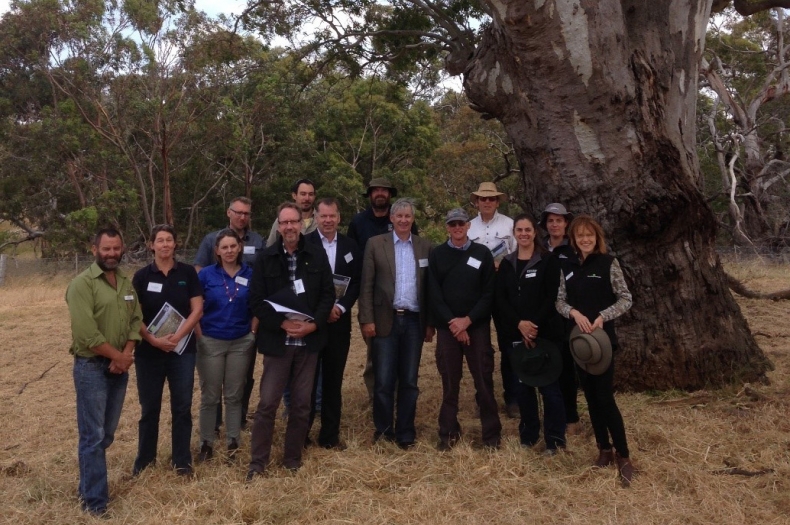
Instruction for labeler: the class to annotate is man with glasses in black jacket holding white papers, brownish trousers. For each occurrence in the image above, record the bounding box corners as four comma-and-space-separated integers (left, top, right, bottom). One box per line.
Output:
247, 203, 335, 481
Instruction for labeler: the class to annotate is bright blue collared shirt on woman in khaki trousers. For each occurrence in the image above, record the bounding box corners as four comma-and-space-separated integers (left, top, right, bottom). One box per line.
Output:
198, 263, 252, 341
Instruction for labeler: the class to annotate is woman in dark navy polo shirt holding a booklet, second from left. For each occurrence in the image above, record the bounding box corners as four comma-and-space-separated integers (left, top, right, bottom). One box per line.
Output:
132, 224, 203, 476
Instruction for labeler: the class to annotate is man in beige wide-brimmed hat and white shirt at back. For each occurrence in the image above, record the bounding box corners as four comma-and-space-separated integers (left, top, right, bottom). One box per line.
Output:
468, 182, 520, 418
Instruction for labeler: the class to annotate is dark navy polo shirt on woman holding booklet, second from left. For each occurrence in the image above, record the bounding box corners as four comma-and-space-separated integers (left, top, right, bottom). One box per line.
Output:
132, 261, 203, 353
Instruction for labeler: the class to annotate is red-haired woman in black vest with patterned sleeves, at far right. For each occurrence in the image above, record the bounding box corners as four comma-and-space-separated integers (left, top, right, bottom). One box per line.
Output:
557, 215, 634, 483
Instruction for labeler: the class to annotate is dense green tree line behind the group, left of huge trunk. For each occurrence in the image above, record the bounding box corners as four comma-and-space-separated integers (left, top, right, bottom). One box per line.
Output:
0, 0, 513, 256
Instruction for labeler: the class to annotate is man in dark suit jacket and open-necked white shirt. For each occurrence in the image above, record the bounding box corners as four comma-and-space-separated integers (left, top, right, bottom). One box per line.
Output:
307, 197, 362, 450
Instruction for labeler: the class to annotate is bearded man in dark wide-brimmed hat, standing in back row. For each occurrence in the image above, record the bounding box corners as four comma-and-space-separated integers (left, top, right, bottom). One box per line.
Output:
346, 177, 417, 403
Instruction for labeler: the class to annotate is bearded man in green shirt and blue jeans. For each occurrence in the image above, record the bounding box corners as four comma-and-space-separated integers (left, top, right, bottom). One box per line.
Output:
66, 228, 143, 515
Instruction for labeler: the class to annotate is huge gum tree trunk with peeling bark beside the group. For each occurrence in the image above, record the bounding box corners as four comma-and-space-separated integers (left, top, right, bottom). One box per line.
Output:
464, 0, 772, 390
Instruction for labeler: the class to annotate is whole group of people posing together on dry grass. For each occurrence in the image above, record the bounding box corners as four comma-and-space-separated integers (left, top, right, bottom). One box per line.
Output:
66, 178, 634, 514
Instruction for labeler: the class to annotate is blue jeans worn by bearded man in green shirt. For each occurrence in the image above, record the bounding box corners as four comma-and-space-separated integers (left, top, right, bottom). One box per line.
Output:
73, 357, 129, 513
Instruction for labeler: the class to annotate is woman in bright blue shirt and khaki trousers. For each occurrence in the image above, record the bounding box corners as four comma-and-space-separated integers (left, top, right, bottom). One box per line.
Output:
197, 229, 258, 462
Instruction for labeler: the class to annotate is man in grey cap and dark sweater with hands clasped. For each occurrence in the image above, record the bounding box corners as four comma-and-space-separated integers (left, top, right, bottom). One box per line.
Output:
428, 208, 502, 451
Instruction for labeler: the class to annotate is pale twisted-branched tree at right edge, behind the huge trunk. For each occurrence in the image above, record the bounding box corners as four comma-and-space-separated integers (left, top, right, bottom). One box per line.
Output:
699, 9, 790, 246
